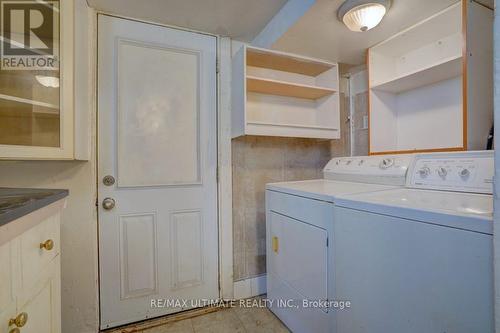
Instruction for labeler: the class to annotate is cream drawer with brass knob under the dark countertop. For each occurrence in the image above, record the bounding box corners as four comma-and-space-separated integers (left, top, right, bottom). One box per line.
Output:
20, 214, 60, 288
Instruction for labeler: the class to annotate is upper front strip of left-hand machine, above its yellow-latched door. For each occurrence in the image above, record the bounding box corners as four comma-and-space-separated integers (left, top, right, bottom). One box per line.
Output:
266, 190, 333, 230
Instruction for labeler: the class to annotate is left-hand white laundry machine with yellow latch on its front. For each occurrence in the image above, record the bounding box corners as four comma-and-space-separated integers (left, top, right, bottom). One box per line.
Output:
266, 155, 412, 333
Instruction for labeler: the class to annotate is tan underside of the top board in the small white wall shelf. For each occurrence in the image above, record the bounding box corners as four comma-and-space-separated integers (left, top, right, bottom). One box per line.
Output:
247, 48, 335, 76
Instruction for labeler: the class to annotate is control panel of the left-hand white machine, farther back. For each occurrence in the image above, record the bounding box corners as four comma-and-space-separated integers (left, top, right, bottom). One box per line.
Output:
323, 154, 413, 185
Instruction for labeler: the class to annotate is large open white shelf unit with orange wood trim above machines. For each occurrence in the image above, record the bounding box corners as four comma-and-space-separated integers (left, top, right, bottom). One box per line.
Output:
367, 0, 493, 154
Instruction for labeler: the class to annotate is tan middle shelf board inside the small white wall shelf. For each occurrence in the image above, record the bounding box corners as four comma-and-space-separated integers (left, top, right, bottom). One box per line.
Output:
247, 76, 335, 100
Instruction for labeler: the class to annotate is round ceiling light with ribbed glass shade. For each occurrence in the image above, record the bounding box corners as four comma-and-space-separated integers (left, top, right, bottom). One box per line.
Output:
337, 0, 391, 32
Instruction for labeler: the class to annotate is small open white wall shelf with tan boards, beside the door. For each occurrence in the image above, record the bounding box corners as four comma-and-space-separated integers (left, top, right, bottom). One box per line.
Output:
232, 46, 340, 139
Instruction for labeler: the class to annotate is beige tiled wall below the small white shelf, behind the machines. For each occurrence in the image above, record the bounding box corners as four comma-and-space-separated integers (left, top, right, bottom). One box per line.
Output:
232, 89, 349, 281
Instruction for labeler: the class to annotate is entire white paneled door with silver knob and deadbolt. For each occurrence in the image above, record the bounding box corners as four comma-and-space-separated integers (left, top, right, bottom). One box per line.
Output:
98, 15, 219, 328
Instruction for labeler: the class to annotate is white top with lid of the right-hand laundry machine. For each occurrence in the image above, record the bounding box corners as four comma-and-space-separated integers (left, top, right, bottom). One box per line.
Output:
335, 188, 493, 234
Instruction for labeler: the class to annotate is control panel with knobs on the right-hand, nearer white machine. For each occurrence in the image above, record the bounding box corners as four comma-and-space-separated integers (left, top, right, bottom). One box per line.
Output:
406, 151, 494, 193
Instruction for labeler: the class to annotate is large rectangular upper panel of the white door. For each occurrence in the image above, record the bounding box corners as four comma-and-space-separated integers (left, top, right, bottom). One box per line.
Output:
117, 40, 200, 186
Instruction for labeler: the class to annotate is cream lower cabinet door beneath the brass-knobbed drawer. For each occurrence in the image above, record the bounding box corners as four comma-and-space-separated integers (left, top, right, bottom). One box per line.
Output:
17, 256, 61, 333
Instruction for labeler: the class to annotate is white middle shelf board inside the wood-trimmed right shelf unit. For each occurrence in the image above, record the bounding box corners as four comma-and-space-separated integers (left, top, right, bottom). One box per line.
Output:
371, 55, 462, 93
